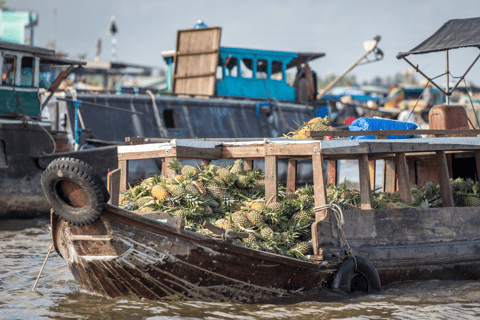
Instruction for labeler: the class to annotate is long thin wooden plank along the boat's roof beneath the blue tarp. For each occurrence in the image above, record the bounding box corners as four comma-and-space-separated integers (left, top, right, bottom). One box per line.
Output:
305, 129, 480, 139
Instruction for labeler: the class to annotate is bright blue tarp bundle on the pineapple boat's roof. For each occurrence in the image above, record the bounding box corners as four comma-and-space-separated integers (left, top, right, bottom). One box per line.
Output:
349, 118, 418, 140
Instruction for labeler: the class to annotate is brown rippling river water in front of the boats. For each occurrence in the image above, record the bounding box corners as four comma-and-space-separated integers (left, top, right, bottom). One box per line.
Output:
0, 219, 480, 319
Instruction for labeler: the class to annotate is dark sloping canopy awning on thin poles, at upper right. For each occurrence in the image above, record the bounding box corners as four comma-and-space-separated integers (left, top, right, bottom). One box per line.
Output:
397, 18, 480, 59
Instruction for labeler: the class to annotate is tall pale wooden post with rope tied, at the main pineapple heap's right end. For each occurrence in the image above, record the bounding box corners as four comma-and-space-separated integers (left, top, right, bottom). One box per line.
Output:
312, 152, 328, 255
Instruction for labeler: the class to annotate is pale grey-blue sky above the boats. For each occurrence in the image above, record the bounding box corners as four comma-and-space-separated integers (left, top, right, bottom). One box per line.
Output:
10, 0, 480, 85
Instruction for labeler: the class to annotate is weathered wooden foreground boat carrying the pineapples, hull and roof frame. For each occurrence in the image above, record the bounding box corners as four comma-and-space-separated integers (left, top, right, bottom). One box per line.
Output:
44, 130, 480, 302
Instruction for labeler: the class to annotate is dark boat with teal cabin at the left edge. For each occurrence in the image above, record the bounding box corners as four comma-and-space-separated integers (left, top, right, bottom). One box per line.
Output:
0, 41, 117, 218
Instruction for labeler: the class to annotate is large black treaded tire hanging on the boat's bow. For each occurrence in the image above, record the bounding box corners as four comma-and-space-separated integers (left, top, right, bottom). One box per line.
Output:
41, 158, 109, 226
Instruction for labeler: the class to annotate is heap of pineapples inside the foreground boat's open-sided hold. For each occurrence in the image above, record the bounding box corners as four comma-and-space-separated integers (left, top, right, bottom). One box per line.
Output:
120, 160, 480, 259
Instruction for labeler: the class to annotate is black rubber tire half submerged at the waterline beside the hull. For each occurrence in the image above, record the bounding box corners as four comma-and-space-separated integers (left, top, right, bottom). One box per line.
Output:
332, 256, 382, 294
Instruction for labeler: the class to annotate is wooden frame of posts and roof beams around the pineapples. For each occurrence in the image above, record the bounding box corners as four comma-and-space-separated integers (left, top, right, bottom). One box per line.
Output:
118, 138, 480, 255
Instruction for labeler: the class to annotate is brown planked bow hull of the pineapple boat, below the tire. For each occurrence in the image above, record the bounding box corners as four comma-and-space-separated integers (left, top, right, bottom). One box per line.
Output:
52, 206, 335, 302
